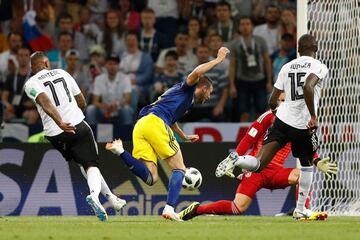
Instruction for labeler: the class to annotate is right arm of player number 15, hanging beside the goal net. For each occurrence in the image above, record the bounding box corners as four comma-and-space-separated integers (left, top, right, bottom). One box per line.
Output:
304, 73, 319, 129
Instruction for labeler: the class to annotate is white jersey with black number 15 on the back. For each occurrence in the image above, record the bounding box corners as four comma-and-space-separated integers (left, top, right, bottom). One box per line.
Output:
274, 56, 329, 129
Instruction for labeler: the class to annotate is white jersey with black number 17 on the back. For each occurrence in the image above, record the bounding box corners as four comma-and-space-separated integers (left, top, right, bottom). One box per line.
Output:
25, 69, 85, 136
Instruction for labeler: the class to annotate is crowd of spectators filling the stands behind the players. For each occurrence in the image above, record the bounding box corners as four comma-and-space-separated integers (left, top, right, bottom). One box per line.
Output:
0, 0, 296, 124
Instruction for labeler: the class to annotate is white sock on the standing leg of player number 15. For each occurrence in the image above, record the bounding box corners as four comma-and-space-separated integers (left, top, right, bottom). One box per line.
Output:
296, 166, 313, 211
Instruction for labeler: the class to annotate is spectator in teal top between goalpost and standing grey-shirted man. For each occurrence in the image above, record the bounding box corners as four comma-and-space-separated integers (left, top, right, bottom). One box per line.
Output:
271, 33, 296, 81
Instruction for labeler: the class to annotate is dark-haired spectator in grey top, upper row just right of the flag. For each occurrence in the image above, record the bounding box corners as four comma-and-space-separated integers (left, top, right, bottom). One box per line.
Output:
57, 12, 89, 63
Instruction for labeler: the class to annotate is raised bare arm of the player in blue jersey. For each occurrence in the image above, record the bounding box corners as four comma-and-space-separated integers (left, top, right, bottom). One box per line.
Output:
186, 47, 230, 86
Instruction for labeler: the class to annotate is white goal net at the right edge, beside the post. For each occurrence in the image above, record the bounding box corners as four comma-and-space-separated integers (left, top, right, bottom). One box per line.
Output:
306, 0, 360, 215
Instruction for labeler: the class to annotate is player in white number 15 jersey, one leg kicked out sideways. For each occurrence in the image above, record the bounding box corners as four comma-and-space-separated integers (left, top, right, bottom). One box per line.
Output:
216, 34, 328, 219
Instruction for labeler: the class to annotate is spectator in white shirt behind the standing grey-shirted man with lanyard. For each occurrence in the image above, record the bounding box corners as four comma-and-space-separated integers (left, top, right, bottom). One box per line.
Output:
254, 5, 281, 55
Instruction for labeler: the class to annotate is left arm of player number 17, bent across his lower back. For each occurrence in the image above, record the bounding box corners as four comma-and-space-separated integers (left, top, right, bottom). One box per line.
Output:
35, 93, 76, 133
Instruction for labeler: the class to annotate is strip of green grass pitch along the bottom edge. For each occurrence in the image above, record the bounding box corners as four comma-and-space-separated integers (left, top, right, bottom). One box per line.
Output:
0, 216, 360, 240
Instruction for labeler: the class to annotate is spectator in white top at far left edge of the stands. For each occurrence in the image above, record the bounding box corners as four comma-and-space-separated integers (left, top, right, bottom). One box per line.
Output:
0, 32, 23, 79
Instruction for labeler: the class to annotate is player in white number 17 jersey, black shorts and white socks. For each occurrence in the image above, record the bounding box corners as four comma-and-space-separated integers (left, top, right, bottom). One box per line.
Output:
25, 52, 126, 221
